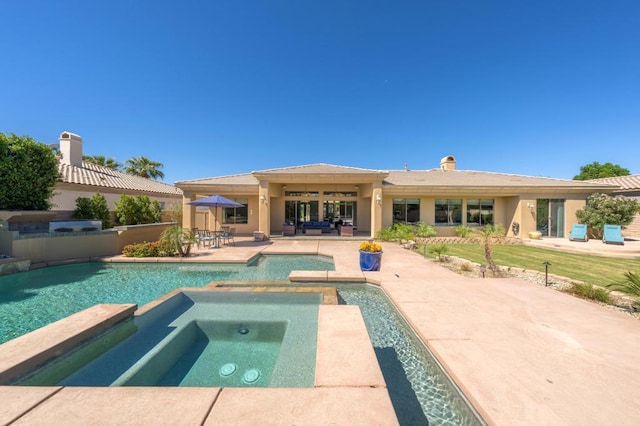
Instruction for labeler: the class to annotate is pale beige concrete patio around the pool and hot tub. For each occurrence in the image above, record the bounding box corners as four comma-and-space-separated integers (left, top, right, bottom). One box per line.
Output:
0, 238, 640, 425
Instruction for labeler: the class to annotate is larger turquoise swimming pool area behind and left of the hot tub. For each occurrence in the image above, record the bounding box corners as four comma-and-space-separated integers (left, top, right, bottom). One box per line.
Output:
0, 255, 335, 343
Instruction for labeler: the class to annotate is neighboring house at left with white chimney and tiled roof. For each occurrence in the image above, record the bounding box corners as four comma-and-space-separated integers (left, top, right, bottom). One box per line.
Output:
51, 132, 182, 219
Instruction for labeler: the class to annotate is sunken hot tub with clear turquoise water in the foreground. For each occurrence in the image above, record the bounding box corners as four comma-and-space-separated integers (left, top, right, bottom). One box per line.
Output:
18, 291, 322, 387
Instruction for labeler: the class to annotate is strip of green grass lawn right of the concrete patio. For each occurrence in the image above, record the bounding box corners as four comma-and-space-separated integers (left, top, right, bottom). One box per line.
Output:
419, 244, 640, 285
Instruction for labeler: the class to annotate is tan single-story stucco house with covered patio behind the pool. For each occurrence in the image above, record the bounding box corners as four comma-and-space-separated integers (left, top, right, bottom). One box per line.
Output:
176, 156, 618, 237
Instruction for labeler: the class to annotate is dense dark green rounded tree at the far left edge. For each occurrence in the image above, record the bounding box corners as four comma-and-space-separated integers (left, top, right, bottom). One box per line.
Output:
0, 133, 60, 210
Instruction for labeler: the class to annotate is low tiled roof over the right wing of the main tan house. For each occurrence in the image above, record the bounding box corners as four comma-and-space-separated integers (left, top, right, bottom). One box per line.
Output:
384, 169, 611, 189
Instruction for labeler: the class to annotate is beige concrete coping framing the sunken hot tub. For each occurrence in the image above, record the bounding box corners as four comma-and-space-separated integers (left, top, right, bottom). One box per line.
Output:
0, 283, 397, 424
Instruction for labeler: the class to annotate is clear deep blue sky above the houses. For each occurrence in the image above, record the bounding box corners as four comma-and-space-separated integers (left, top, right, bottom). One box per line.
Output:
0, 0, 640, 183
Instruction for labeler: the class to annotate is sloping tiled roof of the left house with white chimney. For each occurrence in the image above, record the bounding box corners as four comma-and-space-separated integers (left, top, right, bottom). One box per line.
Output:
58, 162, 182, 195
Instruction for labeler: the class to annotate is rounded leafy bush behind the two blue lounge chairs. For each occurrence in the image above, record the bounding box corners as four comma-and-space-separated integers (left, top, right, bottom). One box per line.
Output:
576, 194, 640, 238
